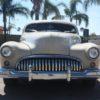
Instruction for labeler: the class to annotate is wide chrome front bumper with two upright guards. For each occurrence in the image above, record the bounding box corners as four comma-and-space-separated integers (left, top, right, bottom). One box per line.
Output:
0, 68, 100, 81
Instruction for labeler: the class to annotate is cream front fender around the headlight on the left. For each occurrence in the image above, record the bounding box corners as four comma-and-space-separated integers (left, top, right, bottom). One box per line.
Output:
0, 41, 31, 67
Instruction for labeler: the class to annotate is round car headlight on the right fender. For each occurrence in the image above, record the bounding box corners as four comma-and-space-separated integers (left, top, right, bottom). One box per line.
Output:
88, 47, 99, 59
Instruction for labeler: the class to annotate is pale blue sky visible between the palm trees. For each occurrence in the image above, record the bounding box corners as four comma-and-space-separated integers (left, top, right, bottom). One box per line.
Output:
0, 0, 100, 35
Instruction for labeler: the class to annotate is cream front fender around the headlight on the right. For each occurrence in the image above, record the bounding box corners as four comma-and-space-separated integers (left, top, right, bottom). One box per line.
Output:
70, 43, 100, 68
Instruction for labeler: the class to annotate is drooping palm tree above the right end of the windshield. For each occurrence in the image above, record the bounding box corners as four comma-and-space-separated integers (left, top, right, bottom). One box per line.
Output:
64, 0, 89, 26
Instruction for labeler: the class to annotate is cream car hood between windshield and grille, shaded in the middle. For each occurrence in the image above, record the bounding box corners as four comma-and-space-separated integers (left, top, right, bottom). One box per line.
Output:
21, 32, 80, 55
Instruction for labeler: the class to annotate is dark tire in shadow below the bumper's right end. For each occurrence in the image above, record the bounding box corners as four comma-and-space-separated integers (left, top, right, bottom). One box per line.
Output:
82, 79, 97, 89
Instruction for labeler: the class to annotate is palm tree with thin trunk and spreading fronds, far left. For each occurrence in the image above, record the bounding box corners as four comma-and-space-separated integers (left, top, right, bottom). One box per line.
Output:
0, 0, 29, 41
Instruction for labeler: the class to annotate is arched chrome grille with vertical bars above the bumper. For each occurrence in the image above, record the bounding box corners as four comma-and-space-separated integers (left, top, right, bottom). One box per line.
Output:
16, 55, 83, 71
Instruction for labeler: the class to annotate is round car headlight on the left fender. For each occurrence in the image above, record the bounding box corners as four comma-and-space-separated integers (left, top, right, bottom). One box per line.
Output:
1, 46, 12, 57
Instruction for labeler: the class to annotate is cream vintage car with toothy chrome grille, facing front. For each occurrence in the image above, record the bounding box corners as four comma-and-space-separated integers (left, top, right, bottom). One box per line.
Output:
0, 20, 100, 86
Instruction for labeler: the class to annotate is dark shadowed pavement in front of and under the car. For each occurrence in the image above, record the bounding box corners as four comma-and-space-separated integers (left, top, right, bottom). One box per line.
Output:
0, 79, 100, 100
